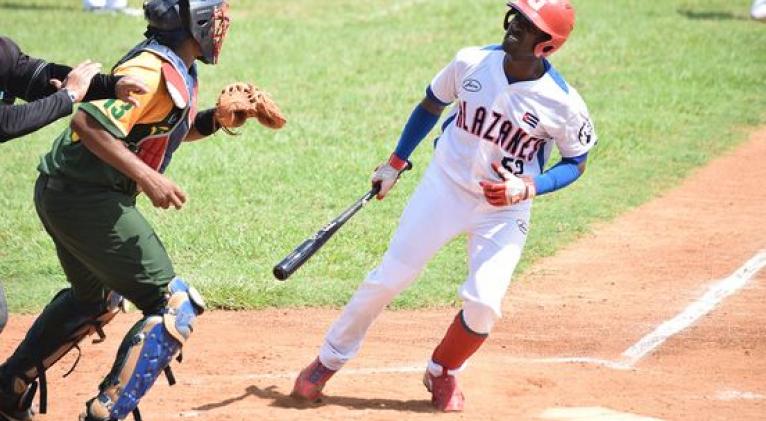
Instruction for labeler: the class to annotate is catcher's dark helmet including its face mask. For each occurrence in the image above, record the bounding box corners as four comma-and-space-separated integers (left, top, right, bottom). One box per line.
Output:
144, 0, 229, 64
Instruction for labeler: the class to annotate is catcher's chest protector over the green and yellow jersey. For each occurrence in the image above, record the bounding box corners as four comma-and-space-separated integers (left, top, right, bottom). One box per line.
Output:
115, 39, 197, 173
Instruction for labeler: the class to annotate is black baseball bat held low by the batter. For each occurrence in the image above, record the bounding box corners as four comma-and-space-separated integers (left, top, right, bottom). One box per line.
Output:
274, 184, 380, 281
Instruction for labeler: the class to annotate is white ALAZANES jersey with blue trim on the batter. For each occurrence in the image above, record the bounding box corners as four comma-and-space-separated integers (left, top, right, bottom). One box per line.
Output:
427, 46, 596, 202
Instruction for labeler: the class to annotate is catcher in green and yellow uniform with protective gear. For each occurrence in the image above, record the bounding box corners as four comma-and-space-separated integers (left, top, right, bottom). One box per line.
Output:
0, 0, 285, 421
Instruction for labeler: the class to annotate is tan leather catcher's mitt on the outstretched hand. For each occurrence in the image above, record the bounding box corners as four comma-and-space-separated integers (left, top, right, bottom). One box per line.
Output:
215, 82, 286, 134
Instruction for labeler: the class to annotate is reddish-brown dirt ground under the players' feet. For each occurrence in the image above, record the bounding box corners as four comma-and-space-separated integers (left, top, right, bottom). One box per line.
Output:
0, 131, 766, 421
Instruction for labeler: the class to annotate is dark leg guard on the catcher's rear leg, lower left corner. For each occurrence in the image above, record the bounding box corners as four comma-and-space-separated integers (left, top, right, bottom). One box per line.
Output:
0, 289, 123, 420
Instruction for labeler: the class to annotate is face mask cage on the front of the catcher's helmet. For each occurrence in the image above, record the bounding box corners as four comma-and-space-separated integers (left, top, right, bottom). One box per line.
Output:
182, 0, 229, 64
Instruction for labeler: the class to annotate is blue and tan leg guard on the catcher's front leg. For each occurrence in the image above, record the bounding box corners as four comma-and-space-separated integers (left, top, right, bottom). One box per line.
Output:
81, 278, 205, 421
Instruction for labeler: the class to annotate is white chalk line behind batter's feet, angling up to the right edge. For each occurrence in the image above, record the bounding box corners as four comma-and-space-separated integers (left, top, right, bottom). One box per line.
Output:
181, 250, 766, 384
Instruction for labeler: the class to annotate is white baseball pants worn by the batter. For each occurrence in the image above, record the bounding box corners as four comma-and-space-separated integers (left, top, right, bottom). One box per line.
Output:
319, 162, 530, 370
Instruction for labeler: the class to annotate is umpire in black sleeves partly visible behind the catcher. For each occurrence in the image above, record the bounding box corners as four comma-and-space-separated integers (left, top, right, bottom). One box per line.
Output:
0, 36, 147, 332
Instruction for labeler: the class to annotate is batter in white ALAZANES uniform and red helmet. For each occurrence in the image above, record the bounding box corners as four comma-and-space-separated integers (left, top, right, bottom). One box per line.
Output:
292, 0, 596, 411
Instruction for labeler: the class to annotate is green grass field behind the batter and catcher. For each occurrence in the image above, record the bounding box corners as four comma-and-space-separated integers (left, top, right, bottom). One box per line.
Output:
0, 0, 766, 311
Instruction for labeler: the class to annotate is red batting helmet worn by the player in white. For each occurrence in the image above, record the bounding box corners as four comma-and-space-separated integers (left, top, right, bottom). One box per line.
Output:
506, 0, 575, 57
